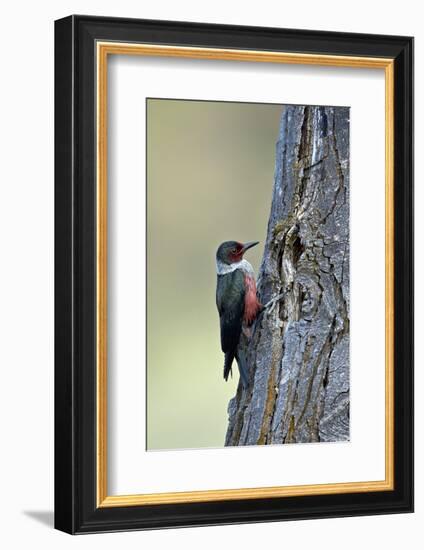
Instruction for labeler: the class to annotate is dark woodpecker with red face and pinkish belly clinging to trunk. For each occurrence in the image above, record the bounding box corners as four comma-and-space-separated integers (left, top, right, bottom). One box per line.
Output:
216, 241, 263, 388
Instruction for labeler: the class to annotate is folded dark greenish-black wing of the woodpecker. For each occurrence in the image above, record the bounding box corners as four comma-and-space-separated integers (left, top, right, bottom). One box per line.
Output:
216, 269, 245, 353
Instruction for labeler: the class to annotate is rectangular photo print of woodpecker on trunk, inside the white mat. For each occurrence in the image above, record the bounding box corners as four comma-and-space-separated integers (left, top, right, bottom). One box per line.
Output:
146, 98, 350, 451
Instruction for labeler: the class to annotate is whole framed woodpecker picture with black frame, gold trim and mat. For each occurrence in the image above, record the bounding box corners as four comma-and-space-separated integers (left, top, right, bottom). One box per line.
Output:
55, 16, 413, 534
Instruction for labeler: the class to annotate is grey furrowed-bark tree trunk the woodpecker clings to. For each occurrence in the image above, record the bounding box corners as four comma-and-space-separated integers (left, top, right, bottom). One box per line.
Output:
225, 106, 349, 445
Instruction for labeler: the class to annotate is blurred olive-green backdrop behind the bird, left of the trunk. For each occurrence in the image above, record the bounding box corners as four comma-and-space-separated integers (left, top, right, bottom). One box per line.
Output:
147, 99, 282, 450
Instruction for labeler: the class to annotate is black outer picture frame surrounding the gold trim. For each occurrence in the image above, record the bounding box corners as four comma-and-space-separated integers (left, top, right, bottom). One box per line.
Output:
55, 15, 413, 534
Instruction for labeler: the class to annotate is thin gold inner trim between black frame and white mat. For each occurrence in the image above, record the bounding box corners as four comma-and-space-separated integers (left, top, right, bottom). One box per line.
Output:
96, 41, 394, 507
